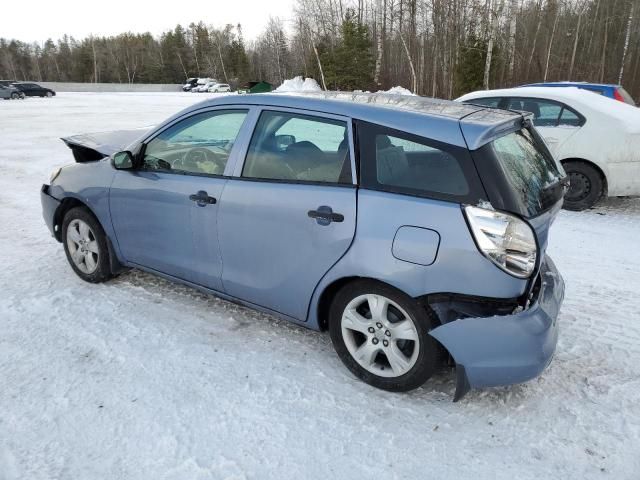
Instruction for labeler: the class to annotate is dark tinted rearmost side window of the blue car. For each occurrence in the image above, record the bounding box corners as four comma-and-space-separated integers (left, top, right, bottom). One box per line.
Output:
357, 122, 482, 201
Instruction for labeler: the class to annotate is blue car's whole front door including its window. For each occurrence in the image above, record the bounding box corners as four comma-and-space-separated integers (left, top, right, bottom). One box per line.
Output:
109, 110, 247, 291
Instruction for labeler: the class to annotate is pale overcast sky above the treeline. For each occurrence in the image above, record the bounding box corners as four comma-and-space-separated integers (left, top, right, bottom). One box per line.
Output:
0, 0, 294, 42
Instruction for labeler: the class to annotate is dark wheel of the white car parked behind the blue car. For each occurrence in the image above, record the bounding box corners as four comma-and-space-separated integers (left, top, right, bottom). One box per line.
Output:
563, 161, 604, 212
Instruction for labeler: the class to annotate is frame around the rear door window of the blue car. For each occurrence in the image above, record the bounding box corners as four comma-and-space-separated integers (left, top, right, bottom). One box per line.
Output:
230, 105, 358, 187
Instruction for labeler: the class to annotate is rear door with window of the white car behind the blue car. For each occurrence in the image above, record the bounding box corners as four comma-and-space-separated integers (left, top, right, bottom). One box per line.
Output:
507, 97, 584, 156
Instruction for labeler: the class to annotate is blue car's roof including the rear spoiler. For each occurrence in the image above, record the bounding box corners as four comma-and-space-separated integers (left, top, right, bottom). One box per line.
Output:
185, 92, 523, 150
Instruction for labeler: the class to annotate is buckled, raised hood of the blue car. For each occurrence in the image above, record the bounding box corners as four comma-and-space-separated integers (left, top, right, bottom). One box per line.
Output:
61, 127, 153, 163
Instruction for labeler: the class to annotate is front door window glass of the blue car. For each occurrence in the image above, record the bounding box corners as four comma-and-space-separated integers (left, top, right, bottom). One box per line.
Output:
142, 110, 247, 175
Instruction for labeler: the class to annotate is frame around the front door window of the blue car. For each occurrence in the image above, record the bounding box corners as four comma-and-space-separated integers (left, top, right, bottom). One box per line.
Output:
135, 104, 255, 178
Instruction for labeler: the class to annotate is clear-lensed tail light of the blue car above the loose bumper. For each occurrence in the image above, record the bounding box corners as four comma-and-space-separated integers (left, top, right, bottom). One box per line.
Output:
464, 206, 538, 278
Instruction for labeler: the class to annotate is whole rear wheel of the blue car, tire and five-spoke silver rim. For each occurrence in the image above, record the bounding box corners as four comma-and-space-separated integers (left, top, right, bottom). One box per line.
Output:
329, 280, 439, 392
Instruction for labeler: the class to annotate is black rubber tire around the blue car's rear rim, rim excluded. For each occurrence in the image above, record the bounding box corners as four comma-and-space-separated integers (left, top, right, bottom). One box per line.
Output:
329, 280, 441, 392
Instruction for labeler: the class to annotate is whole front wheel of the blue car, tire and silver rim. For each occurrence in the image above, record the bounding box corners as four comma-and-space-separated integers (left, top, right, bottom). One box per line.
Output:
62, 207, 112, 283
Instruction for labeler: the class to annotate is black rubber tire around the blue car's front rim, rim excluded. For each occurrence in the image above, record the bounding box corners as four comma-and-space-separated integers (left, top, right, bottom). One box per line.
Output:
62, 207, 113, 283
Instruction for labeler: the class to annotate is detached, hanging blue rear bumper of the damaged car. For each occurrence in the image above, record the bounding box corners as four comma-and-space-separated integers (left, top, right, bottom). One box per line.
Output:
430, 256, 564, 401
